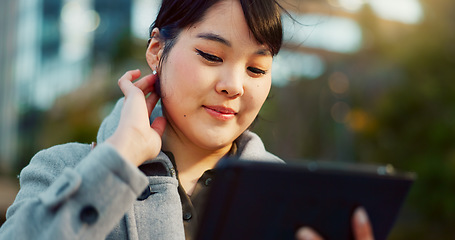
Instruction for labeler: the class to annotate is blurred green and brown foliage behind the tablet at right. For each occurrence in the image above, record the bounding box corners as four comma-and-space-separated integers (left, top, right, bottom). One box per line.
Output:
256, 0, 455, 239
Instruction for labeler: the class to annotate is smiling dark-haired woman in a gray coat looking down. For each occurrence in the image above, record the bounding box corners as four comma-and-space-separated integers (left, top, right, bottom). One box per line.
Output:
0, 0, 371, 239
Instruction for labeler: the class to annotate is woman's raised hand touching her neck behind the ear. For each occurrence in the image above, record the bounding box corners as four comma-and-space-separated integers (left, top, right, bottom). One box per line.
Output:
106, 70, 166, 166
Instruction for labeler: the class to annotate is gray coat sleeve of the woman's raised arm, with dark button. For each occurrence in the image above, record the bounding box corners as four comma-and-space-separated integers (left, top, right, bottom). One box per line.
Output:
0, 143, 148, 240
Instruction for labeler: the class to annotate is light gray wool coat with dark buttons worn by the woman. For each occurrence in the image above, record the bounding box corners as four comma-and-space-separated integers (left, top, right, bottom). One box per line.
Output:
0, 99, 281, 240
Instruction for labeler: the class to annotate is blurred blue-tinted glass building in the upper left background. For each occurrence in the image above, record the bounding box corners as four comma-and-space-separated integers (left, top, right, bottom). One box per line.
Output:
0, 0, 132, 172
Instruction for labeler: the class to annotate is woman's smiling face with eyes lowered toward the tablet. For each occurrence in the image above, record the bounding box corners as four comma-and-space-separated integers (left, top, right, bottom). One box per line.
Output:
149, 0, 272, 150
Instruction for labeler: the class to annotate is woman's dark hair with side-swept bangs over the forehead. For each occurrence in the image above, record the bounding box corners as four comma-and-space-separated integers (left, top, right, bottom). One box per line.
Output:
150, 0, 283, 65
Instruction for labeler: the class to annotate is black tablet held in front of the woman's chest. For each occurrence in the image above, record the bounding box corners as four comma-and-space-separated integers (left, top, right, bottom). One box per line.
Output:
196, 160, 415, 240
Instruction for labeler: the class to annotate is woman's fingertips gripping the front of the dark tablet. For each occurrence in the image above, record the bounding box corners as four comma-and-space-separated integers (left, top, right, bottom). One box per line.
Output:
295, 207, 374, 240
